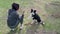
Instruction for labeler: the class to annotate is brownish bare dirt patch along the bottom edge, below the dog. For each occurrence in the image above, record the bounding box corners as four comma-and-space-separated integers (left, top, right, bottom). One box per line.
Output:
26, 24, 56, 34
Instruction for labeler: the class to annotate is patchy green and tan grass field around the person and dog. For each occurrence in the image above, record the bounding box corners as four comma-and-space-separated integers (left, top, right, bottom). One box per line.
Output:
0, 0, 60, 34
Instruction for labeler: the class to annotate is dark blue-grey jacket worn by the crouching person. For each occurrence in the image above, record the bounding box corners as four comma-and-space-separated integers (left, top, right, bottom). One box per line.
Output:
7, 9, 24, 28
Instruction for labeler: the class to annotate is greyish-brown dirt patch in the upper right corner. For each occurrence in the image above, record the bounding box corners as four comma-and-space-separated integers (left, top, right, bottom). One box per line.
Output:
45, 1, 60, 18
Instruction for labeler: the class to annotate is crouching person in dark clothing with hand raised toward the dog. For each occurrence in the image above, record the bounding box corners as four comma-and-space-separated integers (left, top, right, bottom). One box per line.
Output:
7, 3, 24, 30
